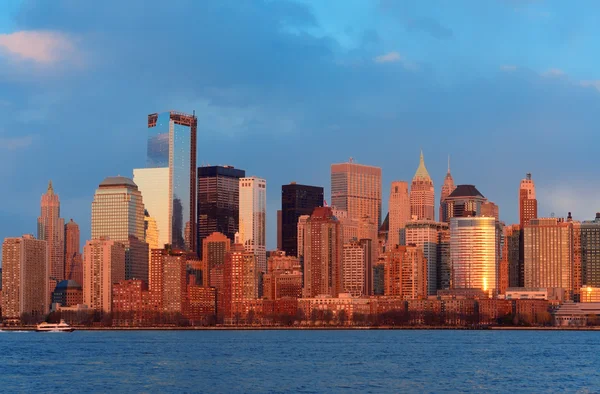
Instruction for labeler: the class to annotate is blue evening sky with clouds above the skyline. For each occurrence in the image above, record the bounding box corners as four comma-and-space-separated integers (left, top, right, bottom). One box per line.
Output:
0, 0, 600, 252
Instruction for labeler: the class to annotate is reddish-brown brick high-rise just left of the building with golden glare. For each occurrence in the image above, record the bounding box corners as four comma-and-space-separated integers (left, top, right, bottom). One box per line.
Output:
383, 245, 427, 300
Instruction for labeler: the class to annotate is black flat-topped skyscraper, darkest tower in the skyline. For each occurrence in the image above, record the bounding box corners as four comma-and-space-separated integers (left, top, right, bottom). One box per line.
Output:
281, 182, 323, 256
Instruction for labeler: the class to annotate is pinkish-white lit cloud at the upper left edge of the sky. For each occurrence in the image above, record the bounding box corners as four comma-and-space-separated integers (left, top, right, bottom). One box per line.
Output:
0, 30, 75, 65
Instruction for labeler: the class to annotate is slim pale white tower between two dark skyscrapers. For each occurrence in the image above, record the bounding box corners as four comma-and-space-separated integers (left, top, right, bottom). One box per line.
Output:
240, 177, 267, 272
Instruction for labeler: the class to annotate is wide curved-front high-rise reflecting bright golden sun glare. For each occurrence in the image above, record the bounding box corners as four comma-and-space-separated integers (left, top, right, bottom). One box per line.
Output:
450, 216, 498, 297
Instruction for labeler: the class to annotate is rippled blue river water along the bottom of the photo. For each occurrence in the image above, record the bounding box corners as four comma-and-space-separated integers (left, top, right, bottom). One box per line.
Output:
0, 330, 600, 393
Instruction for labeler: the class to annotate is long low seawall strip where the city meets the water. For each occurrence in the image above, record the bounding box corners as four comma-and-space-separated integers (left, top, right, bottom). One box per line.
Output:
0, 326, 600, 332
